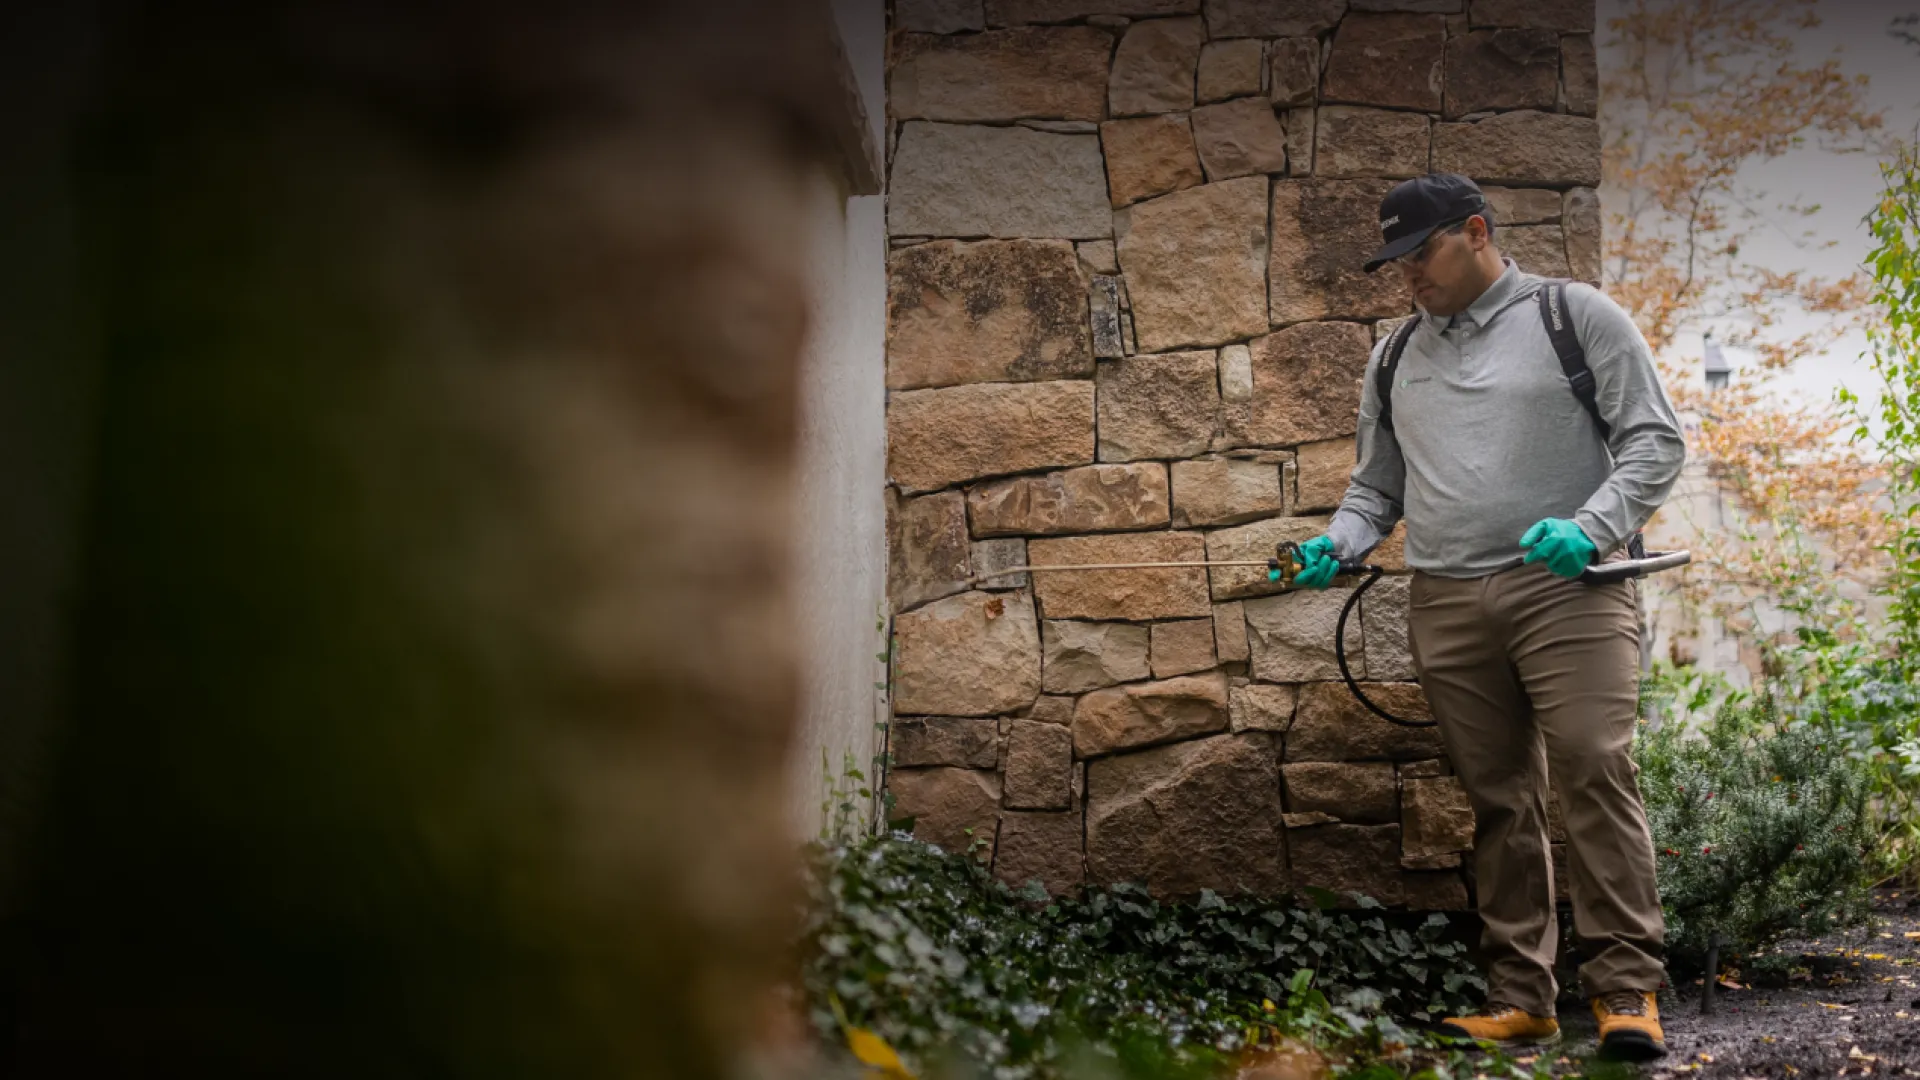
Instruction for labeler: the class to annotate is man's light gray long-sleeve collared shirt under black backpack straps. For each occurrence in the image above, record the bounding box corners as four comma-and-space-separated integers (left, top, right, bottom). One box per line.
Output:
1327, 259, 1686, 578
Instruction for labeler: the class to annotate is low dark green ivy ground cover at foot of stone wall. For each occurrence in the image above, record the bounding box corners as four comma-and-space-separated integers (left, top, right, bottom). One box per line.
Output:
804, 836, 1484, 1080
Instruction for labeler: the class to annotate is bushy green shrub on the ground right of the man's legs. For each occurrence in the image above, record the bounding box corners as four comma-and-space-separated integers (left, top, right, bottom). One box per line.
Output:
1634, 698, 1874, 974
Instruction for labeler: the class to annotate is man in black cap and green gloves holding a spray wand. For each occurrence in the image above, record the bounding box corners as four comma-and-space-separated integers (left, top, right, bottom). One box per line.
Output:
1296, 173, 1686, 1059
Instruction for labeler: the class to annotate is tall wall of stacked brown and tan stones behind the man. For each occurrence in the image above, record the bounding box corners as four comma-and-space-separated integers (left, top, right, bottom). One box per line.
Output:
887, 0, 1599, 909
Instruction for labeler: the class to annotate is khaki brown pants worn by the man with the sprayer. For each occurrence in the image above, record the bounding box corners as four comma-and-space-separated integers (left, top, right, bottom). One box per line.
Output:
1409, 565, 1665, 1017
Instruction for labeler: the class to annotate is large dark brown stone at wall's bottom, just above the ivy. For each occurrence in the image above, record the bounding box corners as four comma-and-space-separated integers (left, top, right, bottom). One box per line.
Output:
1087, 732, 1286, 897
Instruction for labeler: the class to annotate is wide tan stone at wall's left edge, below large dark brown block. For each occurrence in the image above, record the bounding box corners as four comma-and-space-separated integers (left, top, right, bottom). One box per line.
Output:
887, 380, 1094, 492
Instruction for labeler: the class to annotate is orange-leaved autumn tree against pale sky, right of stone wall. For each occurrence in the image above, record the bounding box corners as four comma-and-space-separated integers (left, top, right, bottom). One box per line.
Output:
1601, 0, 1891, 630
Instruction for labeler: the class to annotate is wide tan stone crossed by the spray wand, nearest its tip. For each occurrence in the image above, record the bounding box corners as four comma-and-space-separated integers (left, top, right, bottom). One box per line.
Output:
1027, 532, 1212, 623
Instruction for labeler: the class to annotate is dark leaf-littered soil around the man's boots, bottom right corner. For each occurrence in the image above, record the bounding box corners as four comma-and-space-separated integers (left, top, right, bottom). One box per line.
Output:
1505, 890, 1920, 1080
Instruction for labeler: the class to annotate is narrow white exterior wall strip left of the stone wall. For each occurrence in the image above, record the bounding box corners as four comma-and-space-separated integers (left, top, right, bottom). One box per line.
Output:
789, 0, 887, 838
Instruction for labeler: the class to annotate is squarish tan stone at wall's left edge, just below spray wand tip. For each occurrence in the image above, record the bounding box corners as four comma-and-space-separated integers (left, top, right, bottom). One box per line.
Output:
893, 592, 1041, 717
